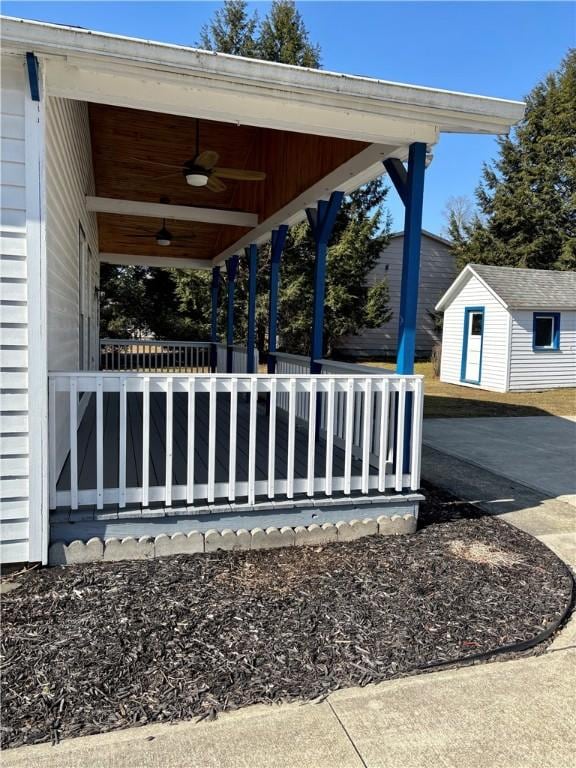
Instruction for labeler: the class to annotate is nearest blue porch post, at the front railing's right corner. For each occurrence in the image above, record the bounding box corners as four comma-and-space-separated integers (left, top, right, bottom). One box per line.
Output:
384, 142, 426, 471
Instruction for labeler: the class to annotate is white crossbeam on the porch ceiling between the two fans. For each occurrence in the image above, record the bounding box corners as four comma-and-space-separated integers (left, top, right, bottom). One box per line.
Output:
86, 195, 258, 227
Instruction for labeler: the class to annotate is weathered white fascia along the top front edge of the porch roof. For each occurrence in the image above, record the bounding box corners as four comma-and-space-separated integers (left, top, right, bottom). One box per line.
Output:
2, 18, 525, 142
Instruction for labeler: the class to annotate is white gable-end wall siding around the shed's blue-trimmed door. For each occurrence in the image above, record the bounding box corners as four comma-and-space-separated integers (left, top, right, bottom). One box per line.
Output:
440, 277, 510, 392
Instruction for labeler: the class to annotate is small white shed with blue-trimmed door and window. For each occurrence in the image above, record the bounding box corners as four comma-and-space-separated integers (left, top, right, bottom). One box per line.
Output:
436, 264, 576, 392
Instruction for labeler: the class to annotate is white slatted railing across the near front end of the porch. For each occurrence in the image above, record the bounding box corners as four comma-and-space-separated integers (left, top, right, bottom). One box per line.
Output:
49, 372, 423, 510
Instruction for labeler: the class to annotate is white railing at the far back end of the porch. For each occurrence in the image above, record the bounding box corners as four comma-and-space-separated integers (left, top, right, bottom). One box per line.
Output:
100, 339, 210, 373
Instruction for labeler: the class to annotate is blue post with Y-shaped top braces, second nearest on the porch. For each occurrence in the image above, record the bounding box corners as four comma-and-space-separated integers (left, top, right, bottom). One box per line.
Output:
306, 192, 344, 373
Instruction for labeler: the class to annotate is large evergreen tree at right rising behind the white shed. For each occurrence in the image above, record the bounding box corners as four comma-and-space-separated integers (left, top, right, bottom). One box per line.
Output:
449, 50, 576, 269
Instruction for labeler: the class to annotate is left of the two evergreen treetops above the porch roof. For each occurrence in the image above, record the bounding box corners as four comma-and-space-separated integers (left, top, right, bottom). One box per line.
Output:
199, 0, 258, 57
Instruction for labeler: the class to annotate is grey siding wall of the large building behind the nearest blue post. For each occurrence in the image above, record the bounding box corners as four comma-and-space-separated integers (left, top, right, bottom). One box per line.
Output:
337, 233, 456, 358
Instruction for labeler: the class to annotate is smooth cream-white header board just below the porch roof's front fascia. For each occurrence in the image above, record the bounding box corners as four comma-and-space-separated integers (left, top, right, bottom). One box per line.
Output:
46, 59, 438, 145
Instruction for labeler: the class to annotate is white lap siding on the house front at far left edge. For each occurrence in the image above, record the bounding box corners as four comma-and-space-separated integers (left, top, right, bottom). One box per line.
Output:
0, 56, 30, 562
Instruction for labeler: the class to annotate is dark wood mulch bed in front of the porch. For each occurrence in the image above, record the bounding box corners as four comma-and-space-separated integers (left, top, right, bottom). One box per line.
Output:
2, 488, 571, 746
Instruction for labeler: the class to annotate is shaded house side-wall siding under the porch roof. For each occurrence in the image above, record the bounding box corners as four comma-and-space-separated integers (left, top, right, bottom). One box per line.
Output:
46, 97, 99, 471
